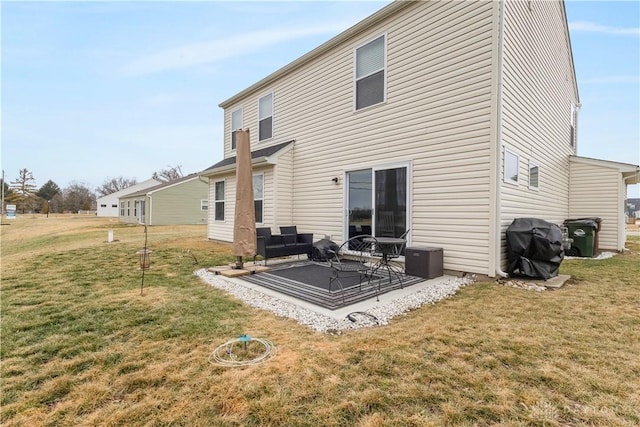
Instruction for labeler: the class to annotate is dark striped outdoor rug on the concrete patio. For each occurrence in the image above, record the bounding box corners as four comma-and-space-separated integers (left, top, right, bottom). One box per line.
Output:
240, 261, 424, 310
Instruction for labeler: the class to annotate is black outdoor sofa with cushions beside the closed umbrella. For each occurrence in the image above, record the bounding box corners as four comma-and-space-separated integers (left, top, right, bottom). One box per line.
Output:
256, 225, 313, 265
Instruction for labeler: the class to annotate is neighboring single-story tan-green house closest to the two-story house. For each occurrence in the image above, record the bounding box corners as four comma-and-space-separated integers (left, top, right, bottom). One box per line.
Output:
119, 174, 209, 225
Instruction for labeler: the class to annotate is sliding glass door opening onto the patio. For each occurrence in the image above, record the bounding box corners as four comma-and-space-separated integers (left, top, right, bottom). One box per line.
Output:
345, 166, 408, 241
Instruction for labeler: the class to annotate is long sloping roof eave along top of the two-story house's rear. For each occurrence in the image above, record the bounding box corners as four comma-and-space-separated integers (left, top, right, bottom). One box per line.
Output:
218, 0, 414, 108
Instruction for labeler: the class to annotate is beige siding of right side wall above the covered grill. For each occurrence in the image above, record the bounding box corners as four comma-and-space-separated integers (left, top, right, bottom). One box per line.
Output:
498, 0, 578, 265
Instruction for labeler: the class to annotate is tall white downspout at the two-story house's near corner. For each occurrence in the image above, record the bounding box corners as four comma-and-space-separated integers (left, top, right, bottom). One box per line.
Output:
494, 1, 508, 277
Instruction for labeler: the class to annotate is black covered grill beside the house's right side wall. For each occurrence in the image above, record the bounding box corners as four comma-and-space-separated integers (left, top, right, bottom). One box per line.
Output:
507, 218, 564, 280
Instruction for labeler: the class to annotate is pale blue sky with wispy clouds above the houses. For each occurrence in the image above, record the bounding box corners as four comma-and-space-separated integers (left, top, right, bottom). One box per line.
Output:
1, 0, 640, 197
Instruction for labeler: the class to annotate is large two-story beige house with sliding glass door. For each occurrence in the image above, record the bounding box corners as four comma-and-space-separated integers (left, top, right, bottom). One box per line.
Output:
200, 0, 639, 276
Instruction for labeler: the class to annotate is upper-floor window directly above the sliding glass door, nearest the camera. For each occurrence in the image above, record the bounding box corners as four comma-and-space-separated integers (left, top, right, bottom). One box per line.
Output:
355, 35, 386, 110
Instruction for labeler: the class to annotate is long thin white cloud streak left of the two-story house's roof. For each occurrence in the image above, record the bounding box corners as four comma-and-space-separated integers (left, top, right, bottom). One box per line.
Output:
120, 23, 356, 76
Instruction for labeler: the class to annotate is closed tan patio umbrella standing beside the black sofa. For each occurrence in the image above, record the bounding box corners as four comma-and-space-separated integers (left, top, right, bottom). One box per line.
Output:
233, 129, 256, 268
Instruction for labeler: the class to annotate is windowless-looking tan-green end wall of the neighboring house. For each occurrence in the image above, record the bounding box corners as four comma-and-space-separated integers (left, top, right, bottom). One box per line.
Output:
147, 178, 208, 225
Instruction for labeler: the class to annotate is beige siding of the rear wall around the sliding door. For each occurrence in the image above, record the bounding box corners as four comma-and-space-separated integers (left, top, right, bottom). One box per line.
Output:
220, 2, 495, 273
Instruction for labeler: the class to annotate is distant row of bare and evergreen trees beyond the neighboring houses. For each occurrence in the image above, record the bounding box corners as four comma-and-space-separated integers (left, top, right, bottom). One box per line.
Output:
0, 166, 183, 214
